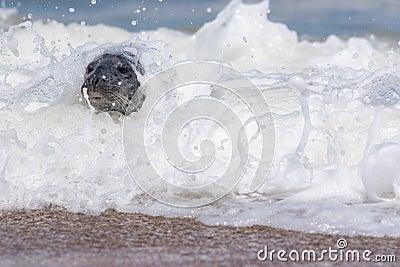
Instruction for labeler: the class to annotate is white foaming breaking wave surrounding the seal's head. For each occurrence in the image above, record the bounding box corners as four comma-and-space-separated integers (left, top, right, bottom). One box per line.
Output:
0, 0, 400, 236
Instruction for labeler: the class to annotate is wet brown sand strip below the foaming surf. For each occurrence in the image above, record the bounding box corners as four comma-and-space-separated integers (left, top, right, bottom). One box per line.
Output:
0, 208, 400, 266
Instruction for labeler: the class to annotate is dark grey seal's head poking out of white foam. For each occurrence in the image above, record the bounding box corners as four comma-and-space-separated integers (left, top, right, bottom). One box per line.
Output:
81, 53, 145, 115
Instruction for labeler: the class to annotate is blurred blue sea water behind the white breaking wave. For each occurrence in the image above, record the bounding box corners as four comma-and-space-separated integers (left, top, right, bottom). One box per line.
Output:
3, 0, 400, 38
